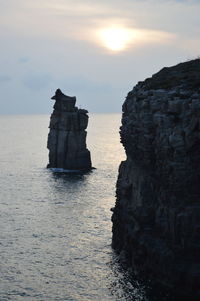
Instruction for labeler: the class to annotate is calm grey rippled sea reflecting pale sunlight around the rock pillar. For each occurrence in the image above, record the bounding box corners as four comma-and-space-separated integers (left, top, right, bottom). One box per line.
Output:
0, 114, 147, 301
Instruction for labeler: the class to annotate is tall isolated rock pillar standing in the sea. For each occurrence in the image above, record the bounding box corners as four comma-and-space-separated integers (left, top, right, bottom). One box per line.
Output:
47, 89, 92, 171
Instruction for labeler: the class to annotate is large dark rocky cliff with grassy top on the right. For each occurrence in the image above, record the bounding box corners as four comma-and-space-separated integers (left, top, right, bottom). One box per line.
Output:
112, 59, 200, 296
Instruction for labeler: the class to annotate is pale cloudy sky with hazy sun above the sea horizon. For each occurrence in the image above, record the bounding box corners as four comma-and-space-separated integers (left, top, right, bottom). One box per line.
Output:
0, 0, 200, 114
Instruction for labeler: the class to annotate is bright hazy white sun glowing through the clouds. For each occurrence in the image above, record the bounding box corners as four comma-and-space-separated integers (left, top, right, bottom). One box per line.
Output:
99, 26, 133, 51
